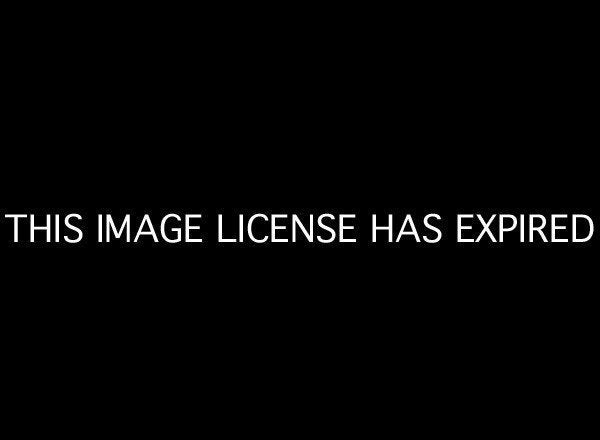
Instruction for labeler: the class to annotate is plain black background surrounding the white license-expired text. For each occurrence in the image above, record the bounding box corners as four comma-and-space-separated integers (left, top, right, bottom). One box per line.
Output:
1, 5, 598, 433
